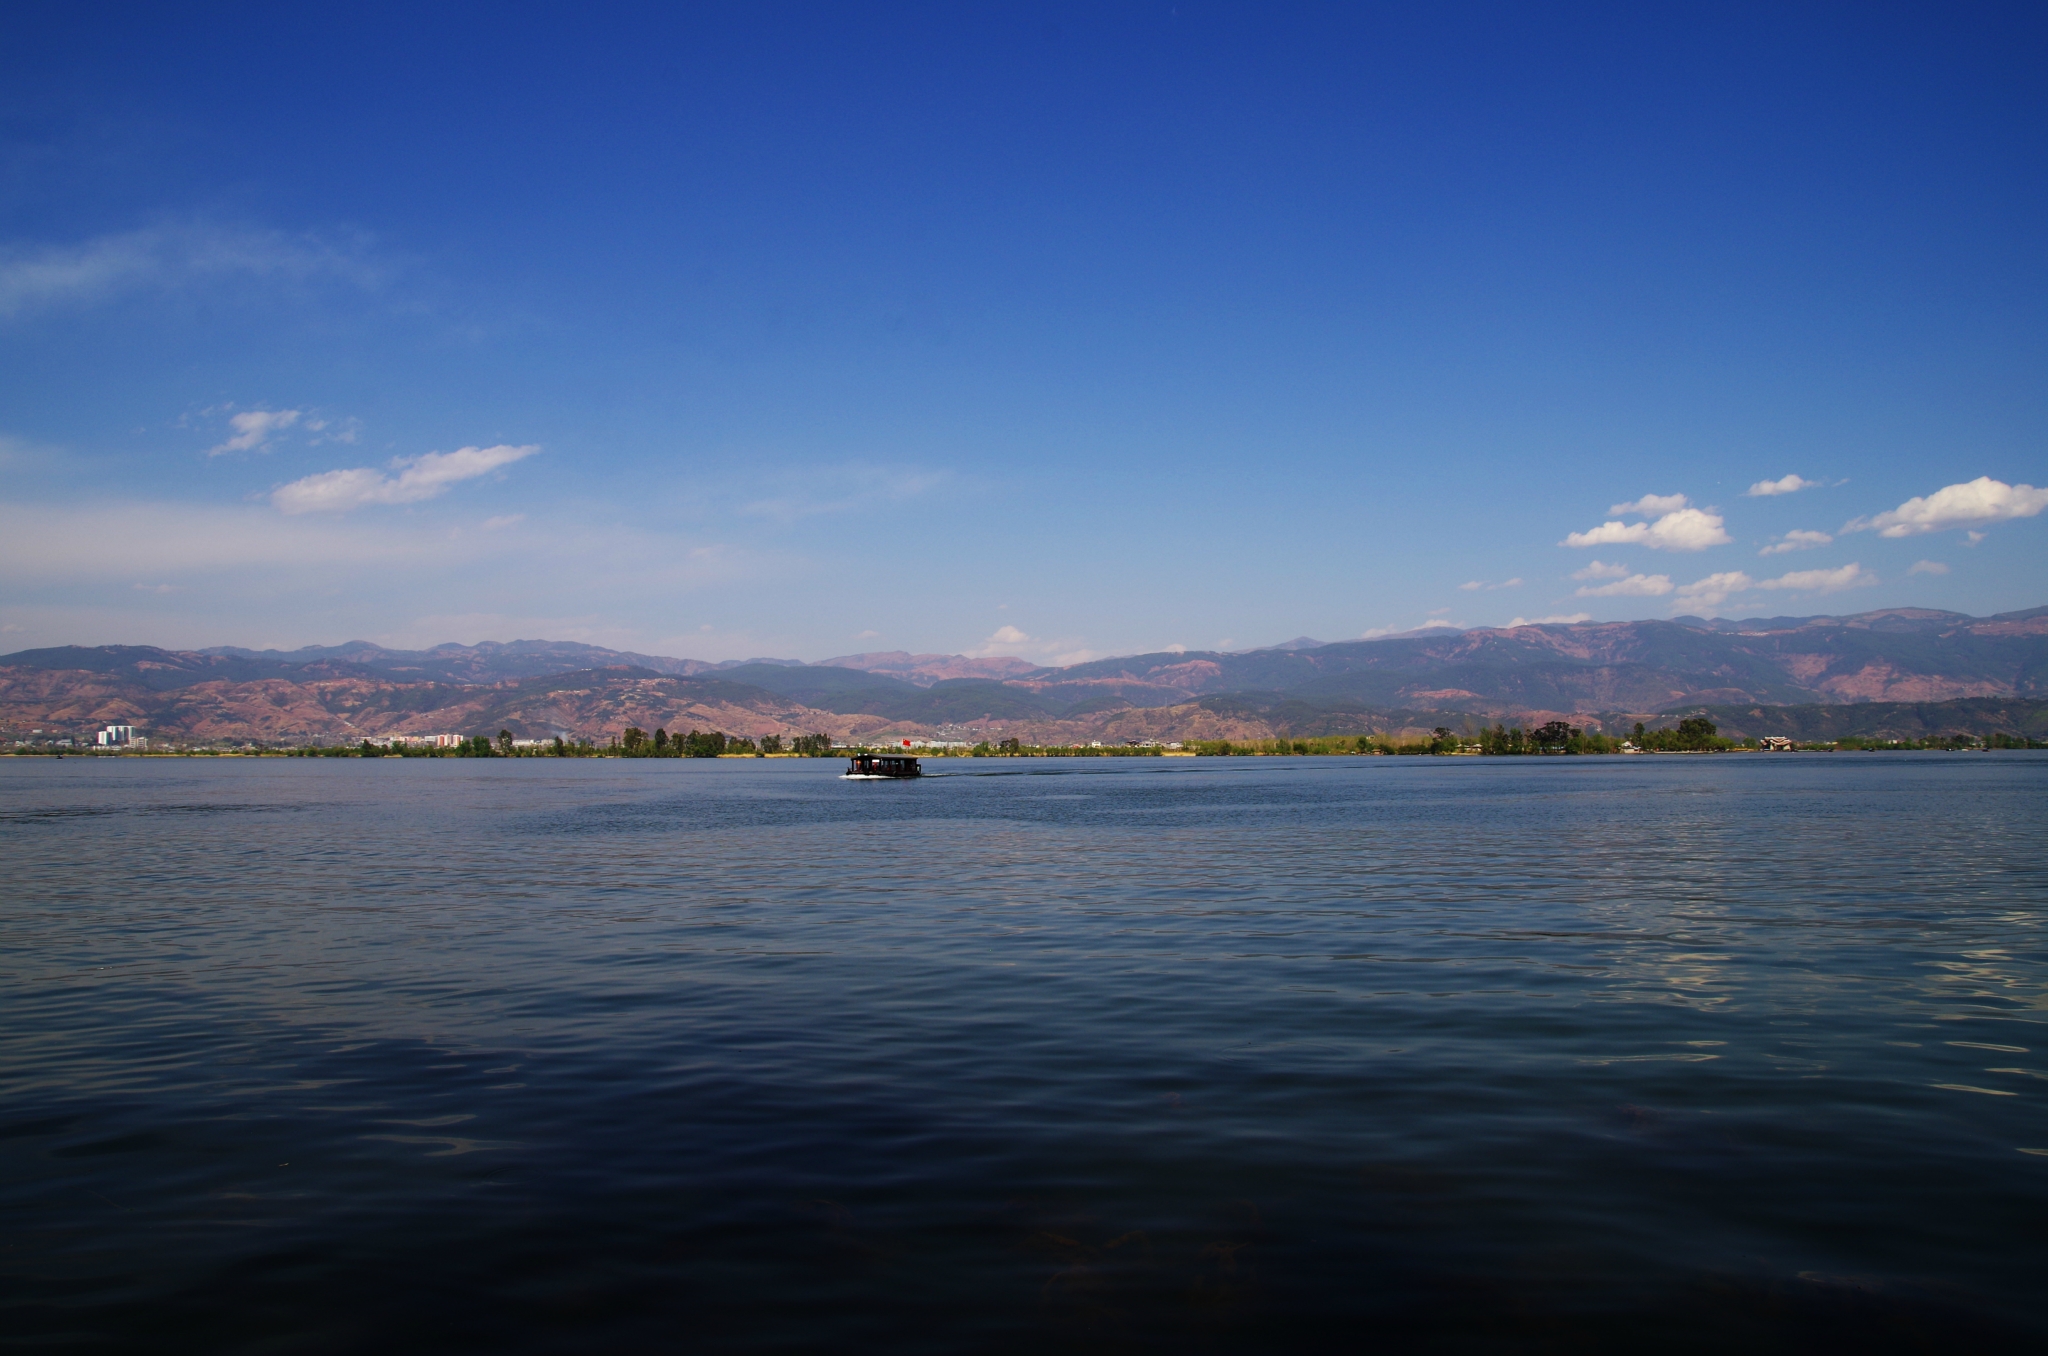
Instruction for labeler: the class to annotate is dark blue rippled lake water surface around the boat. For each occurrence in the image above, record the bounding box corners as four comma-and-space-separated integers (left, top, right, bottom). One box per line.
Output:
0, 754, 2048, 1352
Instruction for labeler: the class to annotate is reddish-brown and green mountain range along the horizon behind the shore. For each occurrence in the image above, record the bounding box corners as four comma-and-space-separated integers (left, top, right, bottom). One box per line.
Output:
0, 608, 2048, 744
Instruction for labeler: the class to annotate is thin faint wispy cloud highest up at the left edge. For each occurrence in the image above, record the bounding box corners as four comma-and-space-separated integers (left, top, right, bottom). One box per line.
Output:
0, 223, 385, 317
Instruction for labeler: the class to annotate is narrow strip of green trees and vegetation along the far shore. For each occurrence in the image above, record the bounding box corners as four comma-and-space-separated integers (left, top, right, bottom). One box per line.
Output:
8, 715, 2048, 758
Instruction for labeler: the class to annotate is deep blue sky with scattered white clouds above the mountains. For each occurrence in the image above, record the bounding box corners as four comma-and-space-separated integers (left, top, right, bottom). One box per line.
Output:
0, 2, 2048, 662
